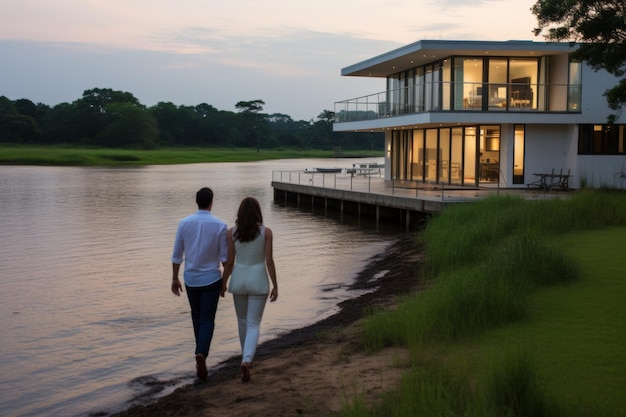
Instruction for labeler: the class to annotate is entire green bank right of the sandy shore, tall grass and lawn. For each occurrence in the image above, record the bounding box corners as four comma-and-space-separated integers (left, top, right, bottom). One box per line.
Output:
341, 192, 626, 417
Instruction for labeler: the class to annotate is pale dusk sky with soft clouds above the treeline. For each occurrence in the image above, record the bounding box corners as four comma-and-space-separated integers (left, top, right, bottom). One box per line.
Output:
0, 0, 543, 121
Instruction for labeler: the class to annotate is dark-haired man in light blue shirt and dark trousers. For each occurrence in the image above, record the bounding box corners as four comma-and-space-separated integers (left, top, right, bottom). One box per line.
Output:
172, 187, 228, 381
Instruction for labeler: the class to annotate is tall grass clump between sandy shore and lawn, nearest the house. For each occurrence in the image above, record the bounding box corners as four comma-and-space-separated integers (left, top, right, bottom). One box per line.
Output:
362, 191, 626, 350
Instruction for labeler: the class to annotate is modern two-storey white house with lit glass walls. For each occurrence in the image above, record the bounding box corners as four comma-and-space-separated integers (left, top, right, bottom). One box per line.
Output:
334, 40, 626, 188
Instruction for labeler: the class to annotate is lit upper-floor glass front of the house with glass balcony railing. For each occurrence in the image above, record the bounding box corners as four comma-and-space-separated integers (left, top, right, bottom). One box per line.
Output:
348, 56, 582, 122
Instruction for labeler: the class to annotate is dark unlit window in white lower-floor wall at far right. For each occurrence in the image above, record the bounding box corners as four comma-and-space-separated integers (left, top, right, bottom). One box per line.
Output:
578, 125, 626, 155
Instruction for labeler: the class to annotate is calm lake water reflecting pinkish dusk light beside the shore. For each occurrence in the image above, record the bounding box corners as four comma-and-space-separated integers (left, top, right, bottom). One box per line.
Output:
0, 159, 401, 416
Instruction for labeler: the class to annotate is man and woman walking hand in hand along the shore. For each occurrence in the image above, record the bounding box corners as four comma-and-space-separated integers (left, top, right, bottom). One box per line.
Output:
172, 187, 278, 382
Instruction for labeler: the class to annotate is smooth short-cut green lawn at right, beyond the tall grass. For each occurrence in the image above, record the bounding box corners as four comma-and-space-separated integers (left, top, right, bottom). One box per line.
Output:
448, 227, 626, 417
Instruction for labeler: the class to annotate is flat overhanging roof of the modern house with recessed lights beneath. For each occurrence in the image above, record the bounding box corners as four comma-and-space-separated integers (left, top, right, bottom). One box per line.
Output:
341, 40, 576, 77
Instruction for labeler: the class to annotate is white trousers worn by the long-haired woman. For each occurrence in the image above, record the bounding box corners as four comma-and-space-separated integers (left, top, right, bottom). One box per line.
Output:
233, 294, 267, 363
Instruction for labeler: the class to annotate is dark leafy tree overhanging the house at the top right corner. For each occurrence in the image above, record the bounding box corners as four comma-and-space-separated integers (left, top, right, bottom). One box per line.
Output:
531, 0, 626, 122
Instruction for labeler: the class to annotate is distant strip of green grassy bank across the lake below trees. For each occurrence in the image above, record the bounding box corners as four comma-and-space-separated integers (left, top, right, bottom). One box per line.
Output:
0, 145, 381, 167
